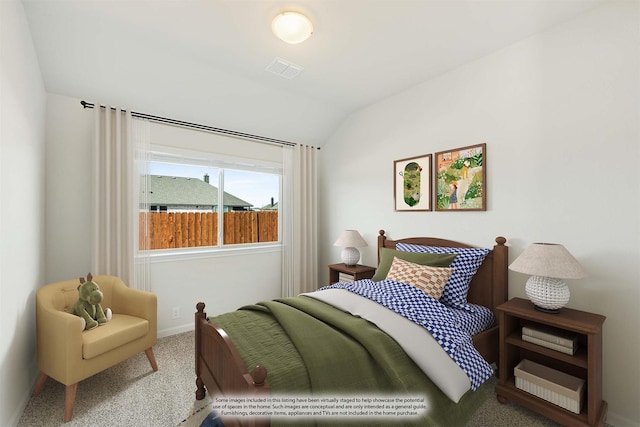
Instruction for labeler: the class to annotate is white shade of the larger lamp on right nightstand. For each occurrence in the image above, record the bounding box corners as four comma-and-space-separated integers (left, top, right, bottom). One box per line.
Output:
509, 243, 587, 279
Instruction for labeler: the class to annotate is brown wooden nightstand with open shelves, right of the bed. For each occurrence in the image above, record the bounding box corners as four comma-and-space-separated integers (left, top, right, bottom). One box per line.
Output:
496, 298, 607, 426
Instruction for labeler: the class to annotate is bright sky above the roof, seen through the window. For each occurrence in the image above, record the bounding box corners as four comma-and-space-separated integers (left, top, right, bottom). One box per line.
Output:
149, 162, 280, 208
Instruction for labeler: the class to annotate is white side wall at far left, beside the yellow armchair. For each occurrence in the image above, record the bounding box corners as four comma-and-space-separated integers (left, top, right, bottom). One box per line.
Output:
0, 1, 45, 426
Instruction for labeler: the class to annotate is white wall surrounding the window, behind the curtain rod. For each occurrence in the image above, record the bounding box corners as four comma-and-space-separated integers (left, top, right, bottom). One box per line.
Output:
46, 94, 281, 336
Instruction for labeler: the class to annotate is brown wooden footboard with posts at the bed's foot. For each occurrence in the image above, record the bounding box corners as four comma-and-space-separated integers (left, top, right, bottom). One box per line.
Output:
195, 302, 270, 426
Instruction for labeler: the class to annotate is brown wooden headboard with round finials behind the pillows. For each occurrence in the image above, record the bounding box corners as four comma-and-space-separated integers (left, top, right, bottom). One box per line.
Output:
378, 230, 509, 312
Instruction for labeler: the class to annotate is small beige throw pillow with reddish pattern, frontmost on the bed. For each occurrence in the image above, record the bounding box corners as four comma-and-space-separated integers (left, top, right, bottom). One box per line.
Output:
387, 257, 453, 300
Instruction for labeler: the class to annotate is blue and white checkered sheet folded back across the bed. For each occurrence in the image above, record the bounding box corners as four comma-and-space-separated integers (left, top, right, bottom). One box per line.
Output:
320, 279, 495, 390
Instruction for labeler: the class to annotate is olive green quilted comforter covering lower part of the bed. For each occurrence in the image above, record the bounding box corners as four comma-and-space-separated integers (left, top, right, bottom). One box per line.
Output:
210, 296, 486, 426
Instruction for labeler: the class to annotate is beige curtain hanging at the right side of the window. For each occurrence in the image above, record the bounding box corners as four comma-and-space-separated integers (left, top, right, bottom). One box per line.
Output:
282, 145, 318, 297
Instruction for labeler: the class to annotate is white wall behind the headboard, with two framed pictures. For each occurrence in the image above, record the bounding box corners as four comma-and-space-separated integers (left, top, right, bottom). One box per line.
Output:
319, 1, 640, 427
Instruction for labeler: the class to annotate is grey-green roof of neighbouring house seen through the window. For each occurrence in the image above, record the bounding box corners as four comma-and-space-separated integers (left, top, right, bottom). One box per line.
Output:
147, 175, 253, 207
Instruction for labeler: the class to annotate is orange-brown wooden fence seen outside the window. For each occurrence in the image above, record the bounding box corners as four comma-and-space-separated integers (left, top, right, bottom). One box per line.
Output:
139, 211, 278, 249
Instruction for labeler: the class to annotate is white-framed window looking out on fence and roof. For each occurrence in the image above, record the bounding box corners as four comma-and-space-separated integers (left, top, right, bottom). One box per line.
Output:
140, 150, 282, 250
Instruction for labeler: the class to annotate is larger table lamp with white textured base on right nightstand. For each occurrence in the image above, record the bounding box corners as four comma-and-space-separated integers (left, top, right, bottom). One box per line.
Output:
509, 243, 587, 313
